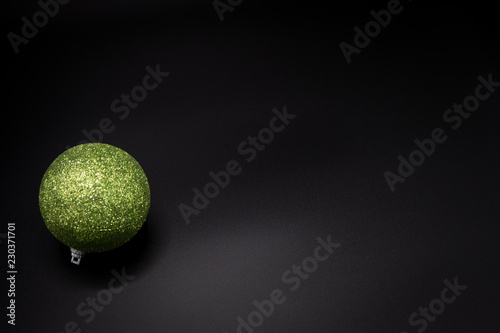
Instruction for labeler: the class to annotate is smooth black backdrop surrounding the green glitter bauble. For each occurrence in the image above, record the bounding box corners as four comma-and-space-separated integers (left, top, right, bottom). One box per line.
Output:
0, 0, 500, 333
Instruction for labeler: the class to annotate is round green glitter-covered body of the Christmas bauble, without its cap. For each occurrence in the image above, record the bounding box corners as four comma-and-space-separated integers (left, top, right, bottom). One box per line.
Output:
39, 143, 150, 252
